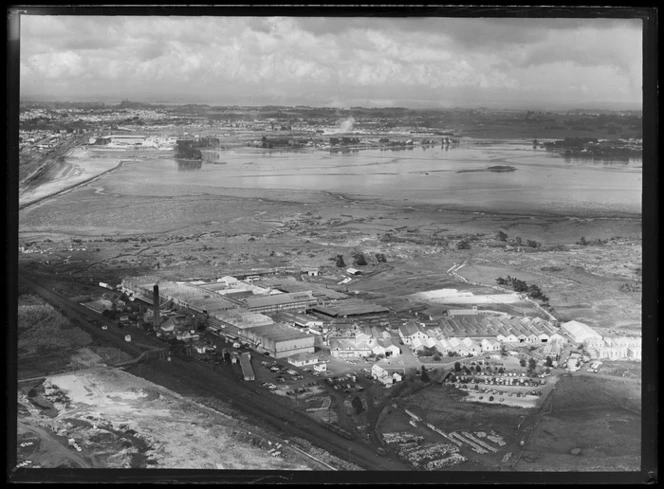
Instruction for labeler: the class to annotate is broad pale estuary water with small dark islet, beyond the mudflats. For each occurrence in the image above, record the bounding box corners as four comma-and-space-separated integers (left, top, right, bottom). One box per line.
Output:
101, 141, 642, 216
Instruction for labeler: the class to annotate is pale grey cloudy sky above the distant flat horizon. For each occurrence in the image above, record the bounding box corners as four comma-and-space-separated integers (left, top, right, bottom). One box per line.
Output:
20, 15, 642, 108
